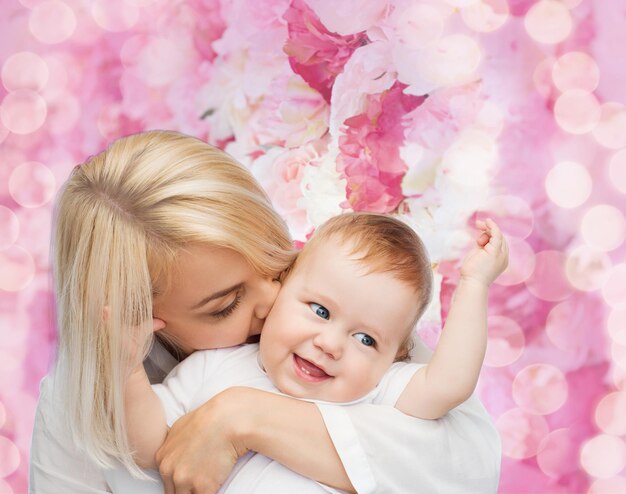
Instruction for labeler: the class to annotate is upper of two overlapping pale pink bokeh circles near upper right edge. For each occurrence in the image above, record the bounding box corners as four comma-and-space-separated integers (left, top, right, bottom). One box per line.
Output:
552, 51, 600, 92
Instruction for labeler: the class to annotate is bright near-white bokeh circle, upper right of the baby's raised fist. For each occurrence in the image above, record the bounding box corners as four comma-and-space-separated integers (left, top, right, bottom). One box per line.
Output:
545, 161, 592, 208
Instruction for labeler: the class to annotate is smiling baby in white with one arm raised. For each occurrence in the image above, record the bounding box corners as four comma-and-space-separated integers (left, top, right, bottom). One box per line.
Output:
126, 213, 508, 490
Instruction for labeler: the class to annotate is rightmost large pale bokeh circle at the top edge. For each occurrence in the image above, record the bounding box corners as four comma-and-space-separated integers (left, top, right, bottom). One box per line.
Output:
524, 0, 572, 45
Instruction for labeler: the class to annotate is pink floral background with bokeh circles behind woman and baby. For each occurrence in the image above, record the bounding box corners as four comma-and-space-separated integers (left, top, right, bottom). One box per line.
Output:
0, 0, 626, 494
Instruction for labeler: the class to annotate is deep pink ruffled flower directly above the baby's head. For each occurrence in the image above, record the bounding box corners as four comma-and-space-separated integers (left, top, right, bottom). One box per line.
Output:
337, 83, 424, 212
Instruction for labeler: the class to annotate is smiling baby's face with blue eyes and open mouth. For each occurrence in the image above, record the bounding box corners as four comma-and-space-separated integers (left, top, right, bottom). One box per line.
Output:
260, 240, 416, 402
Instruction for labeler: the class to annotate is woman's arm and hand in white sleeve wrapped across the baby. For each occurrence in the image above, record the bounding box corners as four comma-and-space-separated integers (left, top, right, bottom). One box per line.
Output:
157, 388, 500, 493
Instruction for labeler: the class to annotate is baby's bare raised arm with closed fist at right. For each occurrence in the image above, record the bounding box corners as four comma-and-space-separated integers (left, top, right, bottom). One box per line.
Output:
396, 219, 508, 419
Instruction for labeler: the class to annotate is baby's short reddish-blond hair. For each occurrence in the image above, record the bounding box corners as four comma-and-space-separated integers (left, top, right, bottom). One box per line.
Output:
288, 213, 433, 361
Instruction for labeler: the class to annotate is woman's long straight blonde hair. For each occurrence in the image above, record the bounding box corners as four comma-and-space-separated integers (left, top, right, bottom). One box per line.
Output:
52, 131, 294, 474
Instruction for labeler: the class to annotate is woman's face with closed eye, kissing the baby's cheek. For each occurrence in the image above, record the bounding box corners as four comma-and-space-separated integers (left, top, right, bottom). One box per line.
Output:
153, 244, 280, 354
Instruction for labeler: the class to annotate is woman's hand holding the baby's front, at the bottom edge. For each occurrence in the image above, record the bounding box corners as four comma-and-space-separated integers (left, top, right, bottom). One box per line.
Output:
156, 388, 252, 494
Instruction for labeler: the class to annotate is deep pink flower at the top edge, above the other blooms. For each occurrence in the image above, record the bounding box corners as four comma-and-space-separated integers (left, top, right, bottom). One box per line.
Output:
283, 0, 367, 102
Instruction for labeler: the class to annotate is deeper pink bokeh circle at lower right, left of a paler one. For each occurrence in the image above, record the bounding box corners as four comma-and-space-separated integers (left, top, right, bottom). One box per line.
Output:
537, 429, 578, 478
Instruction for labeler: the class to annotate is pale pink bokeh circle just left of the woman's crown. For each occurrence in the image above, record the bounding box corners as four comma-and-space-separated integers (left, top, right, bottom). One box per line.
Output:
9, 161, 56, 208
